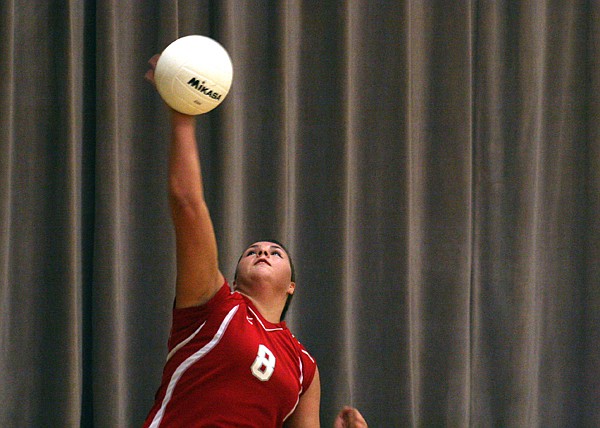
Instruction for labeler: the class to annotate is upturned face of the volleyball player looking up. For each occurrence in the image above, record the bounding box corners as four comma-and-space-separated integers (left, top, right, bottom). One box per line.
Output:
235, 241, 294, 294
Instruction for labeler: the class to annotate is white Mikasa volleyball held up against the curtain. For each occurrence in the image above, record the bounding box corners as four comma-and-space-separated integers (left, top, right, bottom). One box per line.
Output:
154, 35, 233, 115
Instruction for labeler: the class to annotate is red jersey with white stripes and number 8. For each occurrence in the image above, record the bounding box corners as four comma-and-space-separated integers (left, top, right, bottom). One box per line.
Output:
144, 283, 316, 428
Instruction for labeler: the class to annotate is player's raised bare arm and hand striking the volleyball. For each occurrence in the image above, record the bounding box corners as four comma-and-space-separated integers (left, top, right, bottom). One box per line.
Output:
146, 56, 224, 308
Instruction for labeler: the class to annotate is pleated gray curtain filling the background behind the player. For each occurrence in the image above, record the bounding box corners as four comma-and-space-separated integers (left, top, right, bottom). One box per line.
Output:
0, 0, 600, 427
